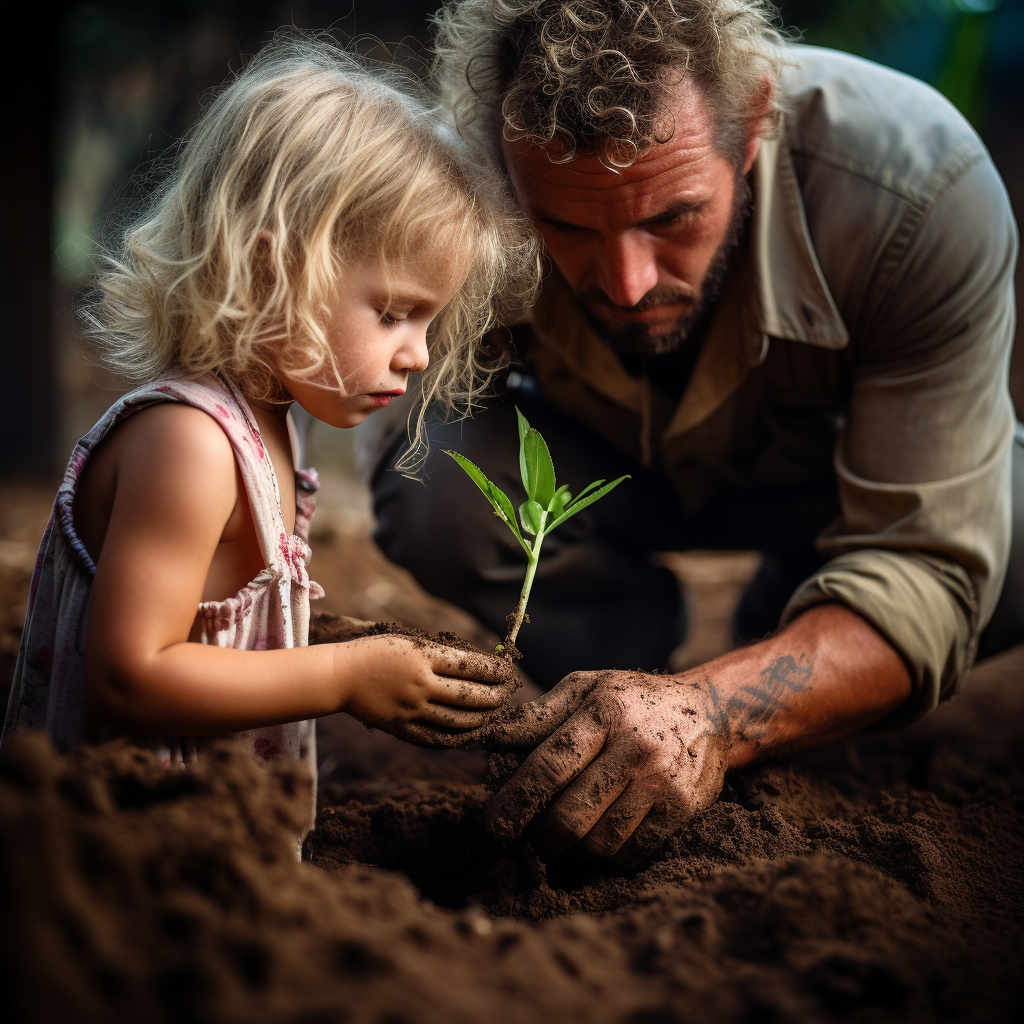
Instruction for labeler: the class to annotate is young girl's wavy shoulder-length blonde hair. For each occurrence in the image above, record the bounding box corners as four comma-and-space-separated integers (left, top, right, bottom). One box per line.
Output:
80, 31, 540, 462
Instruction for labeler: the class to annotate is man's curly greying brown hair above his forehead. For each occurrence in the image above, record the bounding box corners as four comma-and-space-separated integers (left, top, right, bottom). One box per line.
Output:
434, 0, 783, 168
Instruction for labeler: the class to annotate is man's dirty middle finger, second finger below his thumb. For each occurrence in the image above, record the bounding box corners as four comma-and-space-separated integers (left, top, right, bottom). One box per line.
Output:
529, 753, 630, 859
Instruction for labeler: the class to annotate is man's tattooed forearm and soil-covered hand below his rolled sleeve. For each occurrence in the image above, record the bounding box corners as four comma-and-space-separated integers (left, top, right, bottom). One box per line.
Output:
482, 604, 910, 864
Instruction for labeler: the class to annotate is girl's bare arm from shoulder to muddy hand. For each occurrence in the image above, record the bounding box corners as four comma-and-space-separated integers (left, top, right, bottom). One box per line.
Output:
85, 403, 508, 734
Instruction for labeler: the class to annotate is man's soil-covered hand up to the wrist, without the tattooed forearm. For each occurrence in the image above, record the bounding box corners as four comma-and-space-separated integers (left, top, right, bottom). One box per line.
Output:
484, 671, 729, 865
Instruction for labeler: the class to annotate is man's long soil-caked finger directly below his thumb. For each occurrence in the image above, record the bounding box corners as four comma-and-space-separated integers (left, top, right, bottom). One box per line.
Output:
481, 706, 607, 839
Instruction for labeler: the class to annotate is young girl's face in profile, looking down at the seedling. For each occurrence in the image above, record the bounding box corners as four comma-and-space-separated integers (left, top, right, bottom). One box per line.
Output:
281, 265, 459, 427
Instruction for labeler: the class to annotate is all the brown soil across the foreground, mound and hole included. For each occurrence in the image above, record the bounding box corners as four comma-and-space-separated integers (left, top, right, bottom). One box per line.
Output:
0, 654, 1024, 1024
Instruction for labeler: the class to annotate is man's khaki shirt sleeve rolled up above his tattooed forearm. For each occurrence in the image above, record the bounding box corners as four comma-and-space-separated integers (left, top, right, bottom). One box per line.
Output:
782, 157, 1017, 725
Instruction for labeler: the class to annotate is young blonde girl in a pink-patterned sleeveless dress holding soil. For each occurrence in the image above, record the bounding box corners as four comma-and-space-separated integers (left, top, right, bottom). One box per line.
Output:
4, 37, 537, 798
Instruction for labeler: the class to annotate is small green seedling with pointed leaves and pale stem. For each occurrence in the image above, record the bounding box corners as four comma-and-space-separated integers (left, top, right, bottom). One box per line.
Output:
444, 409, 629, 656
